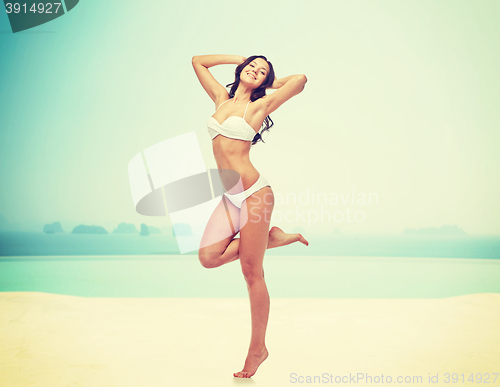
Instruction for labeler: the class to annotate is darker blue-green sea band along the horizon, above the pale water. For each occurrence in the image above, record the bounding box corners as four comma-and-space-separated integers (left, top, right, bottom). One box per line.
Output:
0, 232, 500, 259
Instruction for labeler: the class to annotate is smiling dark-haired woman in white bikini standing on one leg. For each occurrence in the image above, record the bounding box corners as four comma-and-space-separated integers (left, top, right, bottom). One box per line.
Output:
192, 55, 309, 378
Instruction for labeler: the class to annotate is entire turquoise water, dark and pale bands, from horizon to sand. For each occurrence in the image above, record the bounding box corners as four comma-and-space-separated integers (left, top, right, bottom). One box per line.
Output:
0, 233, 500, 298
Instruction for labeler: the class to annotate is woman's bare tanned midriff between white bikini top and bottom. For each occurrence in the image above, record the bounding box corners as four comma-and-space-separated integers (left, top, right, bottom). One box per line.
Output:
212, 135, 259, 190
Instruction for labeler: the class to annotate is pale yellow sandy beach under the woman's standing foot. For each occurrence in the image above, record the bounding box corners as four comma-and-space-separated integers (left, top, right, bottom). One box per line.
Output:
0, 292, 500, 387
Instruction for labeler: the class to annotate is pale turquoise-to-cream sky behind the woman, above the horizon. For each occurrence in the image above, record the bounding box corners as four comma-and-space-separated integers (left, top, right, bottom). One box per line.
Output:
0, 0, 500, 234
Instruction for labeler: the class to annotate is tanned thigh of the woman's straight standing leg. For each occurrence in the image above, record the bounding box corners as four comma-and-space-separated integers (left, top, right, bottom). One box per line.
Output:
239, 187, 274, 274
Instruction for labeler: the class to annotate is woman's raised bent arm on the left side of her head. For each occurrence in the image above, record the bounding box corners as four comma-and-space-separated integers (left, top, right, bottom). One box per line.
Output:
191, 55, 246, 104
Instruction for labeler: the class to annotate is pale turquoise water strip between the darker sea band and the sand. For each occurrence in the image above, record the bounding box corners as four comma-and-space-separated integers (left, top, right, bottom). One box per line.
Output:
0, 255, 500, 298
